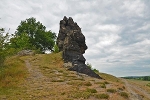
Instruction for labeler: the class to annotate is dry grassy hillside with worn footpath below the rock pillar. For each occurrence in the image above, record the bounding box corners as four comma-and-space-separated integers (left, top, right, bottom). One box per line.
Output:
0, 53, 128, 100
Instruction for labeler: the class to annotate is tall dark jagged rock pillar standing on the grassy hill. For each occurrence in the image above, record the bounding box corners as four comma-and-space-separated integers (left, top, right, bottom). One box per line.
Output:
57, 16, 101, 78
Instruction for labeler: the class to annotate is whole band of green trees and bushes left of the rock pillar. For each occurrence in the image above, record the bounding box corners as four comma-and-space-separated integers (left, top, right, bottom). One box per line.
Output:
0, 17, 59, 67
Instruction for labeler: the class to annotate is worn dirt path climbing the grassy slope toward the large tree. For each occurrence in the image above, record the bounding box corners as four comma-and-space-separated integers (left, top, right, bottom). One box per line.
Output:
24, 60, 52, 100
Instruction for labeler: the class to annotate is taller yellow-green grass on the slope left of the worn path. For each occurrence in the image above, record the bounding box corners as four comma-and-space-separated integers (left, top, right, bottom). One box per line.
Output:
0, 56, 28, 99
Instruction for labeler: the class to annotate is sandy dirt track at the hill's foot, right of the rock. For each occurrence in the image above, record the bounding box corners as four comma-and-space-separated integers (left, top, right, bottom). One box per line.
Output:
123, 79, 150, 100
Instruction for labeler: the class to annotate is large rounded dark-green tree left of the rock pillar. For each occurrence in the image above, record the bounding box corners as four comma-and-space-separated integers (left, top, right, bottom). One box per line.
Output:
11, 17, 56, 52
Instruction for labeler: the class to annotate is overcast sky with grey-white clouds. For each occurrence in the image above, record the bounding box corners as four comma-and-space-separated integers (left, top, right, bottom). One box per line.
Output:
0, 0, 150, 76
